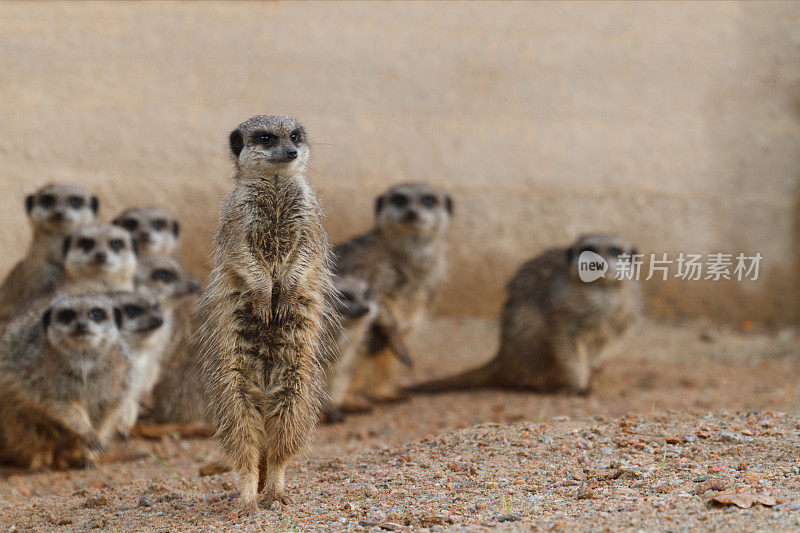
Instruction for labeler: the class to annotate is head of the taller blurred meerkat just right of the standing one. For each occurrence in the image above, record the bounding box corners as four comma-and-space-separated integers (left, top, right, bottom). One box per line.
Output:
375, 183, 453, 240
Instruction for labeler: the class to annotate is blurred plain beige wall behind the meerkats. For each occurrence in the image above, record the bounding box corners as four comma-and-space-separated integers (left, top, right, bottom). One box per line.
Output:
0, 3, 800, 319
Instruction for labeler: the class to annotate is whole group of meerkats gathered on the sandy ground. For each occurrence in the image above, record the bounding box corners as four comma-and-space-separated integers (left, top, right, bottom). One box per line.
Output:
0, 115, 640, 513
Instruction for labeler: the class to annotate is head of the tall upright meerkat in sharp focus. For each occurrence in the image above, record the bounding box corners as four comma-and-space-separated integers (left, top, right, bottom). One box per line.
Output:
228, 115, 311, 174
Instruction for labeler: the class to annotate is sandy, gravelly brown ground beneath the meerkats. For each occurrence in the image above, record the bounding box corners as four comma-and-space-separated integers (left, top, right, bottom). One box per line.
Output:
0, 320, 800, 531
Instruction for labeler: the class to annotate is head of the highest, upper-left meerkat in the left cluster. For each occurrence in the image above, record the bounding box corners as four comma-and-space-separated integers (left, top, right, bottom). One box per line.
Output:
25, 185, 100, 235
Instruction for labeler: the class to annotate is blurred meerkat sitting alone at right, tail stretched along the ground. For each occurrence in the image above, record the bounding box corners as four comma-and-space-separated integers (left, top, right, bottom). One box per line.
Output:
410, 234, 641, 394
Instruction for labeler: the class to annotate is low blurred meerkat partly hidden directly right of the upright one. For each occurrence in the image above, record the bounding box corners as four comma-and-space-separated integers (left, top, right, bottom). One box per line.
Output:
324, 276, 380, 422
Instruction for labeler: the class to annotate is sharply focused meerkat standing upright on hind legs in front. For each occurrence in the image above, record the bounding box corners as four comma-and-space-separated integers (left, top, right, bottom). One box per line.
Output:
201, 115, 335, 512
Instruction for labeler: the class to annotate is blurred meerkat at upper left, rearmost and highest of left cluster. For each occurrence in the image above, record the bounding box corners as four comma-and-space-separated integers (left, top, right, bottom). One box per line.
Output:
0, 185, 99, 320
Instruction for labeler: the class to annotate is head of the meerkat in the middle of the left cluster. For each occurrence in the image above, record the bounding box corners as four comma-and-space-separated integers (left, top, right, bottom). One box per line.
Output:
64, 224, 136, 288
